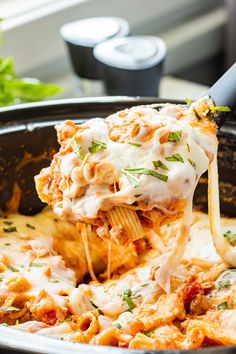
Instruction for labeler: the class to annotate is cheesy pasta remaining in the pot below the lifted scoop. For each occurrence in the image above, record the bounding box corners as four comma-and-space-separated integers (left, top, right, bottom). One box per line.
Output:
0, 211, 236, 349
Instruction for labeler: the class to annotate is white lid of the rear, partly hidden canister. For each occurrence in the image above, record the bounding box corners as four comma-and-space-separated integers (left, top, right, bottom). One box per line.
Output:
61, 17, 129, 47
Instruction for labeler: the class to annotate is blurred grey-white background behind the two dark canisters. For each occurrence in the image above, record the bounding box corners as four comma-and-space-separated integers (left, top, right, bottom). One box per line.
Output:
0, 0, 236, 99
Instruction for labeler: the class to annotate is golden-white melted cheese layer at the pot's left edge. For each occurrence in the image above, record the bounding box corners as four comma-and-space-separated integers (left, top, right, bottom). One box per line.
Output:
0, 211, 75, 309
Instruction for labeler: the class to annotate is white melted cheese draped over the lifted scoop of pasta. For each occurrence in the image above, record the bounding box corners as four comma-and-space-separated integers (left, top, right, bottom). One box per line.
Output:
54, 106, 217, 220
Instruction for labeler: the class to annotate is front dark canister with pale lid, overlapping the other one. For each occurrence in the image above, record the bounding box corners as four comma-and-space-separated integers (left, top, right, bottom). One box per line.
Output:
94, 36, 166, 96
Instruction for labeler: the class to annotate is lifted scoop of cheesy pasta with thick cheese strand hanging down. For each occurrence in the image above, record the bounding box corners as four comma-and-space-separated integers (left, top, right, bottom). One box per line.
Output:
35, 99, 217, 291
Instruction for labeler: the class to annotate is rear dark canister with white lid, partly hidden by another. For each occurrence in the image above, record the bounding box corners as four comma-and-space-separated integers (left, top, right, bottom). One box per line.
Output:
61, 17, 129, 95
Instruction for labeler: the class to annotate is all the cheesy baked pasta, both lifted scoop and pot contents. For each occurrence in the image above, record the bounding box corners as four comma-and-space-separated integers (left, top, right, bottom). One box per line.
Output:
0, 98, 236, 349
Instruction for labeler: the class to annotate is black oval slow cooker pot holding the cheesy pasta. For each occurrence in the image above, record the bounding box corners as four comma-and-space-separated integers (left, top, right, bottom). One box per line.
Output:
0, 97, 236, 354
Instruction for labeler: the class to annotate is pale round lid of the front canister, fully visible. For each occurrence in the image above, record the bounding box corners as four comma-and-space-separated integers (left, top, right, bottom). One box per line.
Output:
94, 36, 166, 70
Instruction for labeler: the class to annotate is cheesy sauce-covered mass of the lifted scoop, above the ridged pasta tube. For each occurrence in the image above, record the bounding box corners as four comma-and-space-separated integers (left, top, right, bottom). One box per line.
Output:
36, 100, 217, 222
